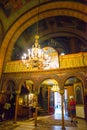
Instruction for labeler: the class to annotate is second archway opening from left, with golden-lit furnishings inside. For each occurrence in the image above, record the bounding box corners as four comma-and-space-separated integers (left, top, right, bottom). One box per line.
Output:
17, 80, 33, 119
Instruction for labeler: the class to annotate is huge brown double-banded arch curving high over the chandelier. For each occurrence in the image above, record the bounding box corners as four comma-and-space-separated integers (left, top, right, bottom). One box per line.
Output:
0, 2, 87, 76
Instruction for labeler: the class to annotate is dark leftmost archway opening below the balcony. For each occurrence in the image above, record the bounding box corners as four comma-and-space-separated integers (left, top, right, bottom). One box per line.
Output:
3, 80, 16, 119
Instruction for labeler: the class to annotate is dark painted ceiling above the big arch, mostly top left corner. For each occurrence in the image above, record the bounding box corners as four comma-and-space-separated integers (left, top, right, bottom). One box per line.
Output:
0, 0, 87, 17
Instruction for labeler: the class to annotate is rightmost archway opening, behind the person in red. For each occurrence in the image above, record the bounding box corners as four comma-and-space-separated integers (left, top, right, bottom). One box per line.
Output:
64, 76, 85, 118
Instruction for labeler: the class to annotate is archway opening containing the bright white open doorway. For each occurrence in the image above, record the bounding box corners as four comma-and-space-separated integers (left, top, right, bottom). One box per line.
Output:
38, 79, 61, 114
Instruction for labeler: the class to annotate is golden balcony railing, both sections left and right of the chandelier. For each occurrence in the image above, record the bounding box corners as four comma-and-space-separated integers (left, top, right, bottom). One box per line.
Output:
4, 52, 87, 73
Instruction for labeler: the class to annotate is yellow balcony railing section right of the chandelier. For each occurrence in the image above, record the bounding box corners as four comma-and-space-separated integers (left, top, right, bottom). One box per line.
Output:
60, 52, 87, 68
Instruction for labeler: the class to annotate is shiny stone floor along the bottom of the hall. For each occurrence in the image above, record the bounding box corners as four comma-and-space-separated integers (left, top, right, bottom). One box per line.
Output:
0, 115, 87, 130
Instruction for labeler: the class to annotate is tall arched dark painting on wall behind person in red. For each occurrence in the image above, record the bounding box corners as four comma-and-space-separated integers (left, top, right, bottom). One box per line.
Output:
74, 83, 83, 105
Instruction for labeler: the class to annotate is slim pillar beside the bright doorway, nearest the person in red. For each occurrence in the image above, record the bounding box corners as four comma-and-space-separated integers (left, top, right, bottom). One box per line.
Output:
59, 89, 65, 130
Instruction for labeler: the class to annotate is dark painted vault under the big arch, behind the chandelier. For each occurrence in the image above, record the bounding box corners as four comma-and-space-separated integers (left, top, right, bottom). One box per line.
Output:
11, 16, 87, 60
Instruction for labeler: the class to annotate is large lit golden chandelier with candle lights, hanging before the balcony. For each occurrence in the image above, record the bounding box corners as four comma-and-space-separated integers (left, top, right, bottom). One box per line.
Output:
22, 1, 51, 68
